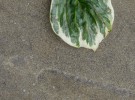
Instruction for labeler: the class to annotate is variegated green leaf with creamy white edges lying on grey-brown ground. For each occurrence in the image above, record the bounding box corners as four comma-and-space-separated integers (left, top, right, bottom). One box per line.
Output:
50, 0, 114, 51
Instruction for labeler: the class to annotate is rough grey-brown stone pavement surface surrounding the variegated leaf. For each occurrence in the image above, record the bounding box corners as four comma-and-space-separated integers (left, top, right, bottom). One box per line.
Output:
0, 0, 135, 100
